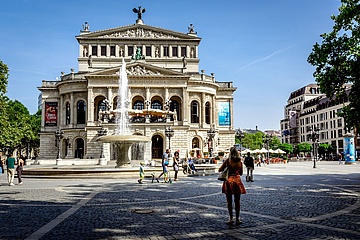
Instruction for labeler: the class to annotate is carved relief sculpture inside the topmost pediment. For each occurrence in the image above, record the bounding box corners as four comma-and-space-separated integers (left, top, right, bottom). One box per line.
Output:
99, 27, 179, 39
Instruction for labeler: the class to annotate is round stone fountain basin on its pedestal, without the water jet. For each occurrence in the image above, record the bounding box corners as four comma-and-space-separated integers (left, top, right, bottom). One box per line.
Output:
96, 135, 151, 167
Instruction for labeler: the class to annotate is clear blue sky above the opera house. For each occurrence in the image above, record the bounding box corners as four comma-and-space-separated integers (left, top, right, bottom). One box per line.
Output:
0, 0, 341, 130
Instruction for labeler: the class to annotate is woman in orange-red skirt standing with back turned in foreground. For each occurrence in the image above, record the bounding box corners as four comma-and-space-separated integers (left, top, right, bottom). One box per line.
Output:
219, 147, 246, 225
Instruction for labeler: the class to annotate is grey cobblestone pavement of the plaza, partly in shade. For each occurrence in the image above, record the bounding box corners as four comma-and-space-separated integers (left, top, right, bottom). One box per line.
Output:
0, 162, 360, 240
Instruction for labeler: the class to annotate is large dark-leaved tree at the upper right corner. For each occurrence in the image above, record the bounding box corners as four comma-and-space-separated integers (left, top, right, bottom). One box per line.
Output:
308, 0, 360, 131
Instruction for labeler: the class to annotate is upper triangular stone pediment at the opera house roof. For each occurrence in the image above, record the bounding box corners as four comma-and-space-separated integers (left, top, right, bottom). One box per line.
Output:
76, 24, 201, 41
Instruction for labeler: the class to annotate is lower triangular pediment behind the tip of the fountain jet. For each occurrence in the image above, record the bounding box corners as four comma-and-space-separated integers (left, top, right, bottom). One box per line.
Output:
86, 62, 189, 78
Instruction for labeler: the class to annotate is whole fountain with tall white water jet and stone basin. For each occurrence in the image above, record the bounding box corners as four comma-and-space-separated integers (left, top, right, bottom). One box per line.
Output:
96, 59, 150, 167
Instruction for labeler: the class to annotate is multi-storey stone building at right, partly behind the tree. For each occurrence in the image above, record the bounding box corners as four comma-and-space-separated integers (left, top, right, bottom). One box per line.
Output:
280, 84, 360, 156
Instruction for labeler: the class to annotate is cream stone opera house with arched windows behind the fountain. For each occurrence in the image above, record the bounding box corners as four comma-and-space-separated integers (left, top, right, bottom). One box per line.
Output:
38, 13, 236, 164
